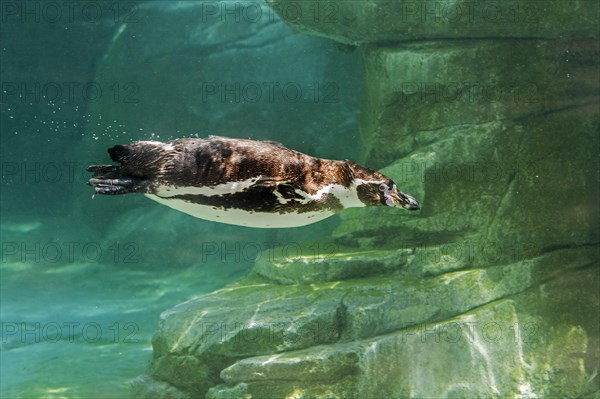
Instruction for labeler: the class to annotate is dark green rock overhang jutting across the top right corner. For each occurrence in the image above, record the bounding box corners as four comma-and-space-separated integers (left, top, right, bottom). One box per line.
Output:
267, 0, 598, 45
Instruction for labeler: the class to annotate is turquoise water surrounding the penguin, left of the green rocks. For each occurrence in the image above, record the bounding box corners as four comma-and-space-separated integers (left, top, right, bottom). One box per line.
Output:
0, 1, 360, 399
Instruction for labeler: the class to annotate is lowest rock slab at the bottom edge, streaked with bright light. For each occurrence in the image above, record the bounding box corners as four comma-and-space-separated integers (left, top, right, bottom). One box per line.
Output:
207, 301, 527, 399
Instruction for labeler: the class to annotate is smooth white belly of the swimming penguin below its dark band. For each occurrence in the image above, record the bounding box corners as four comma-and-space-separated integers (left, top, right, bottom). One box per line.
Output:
145, 194, 335, 228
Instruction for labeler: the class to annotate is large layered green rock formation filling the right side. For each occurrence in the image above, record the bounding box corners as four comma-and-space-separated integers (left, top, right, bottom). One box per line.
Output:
132, 1, 600, 399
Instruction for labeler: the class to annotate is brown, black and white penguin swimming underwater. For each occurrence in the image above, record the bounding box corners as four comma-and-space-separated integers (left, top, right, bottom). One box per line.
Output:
87, 136, 419, 228
